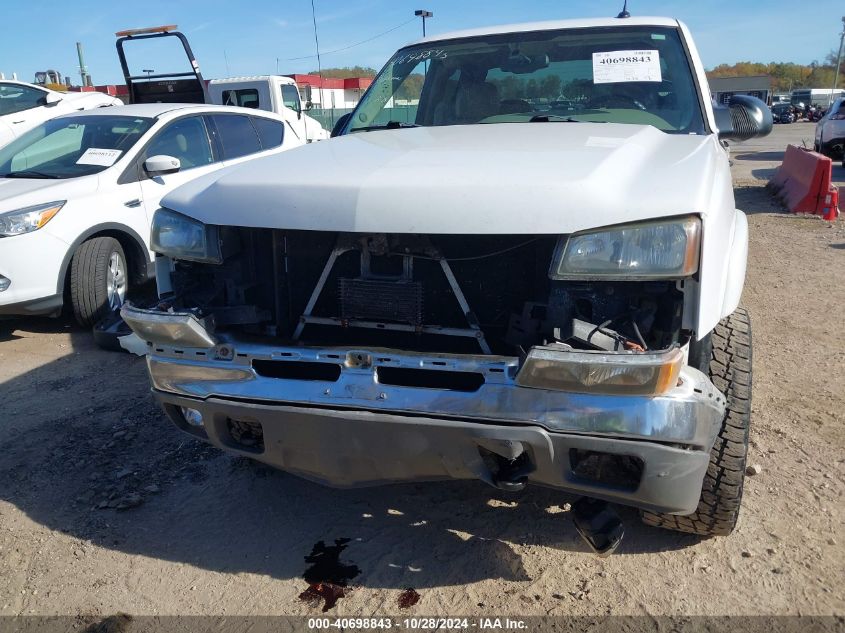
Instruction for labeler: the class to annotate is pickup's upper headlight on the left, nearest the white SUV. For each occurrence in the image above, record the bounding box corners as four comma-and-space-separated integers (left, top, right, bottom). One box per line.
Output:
150, 209, 223, 264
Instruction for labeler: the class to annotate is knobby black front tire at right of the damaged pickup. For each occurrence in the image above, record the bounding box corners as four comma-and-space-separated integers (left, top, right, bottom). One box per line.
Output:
642, 307, 752, 536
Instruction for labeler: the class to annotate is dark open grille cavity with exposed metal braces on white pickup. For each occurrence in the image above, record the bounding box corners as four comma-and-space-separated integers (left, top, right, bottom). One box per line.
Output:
160, 228, 684, 356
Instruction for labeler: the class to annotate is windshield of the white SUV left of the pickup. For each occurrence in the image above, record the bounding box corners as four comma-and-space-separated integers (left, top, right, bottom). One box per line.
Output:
0, 115, 154, 178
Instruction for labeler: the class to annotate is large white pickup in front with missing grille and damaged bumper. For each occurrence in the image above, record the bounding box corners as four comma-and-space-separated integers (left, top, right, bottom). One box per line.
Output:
122, 18, 772, 553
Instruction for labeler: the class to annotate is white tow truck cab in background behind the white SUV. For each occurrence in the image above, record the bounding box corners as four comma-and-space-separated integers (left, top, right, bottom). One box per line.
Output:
208, 75, 329, 143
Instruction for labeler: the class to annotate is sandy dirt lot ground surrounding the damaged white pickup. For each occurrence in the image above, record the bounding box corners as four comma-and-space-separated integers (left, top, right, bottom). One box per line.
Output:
0, 124, 845, 621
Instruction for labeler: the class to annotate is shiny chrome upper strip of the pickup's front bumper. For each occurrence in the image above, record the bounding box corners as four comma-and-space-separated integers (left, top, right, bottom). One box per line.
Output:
124, 308, 725, 444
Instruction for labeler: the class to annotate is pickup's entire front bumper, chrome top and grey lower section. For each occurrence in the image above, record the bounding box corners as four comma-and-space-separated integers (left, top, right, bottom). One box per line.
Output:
123, 307, 725, 514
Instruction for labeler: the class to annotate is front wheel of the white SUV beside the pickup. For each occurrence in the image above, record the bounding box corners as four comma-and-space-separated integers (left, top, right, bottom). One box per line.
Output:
70, 237, 129, 327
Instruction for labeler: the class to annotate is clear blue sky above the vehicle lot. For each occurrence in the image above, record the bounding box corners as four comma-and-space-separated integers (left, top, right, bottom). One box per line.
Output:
0, 0, 845, 85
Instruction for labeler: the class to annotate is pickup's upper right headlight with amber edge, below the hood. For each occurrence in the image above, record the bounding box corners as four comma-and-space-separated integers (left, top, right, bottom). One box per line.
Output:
549, 216, 701, 280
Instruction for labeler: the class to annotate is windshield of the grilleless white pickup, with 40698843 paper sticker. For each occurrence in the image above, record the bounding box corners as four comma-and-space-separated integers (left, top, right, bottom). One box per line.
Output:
347, 26, 705, 134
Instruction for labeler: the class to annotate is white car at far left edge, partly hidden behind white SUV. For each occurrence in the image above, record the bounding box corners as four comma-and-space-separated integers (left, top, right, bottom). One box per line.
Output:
0, 80, 123, 147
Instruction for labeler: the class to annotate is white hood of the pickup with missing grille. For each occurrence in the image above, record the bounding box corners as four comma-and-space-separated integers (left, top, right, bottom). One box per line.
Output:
162, 122, 727, 234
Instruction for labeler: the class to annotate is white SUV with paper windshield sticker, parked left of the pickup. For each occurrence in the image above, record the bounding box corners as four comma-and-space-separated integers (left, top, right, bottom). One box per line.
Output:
0, 103, 303, 325
